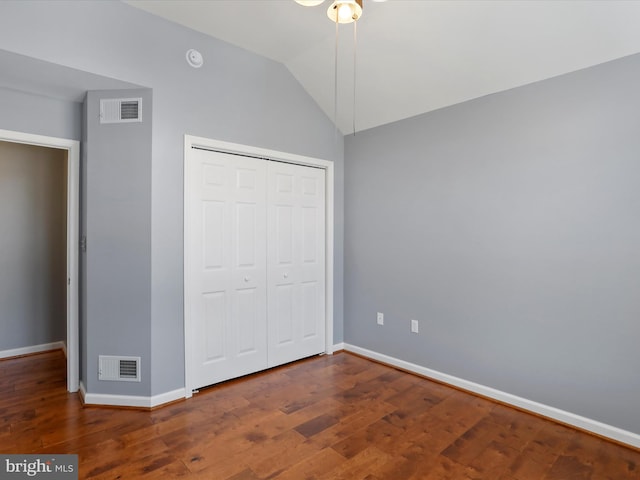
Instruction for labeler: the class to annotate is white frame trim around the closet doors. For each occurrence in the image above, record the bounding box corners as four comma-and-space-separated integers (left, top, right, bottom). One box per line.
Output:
184, 135, 334, 398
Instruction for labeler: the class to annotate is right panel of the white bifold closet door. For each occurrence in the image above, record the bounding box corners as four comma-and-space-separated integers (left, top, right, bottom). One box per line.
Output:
267, 162, 325, 367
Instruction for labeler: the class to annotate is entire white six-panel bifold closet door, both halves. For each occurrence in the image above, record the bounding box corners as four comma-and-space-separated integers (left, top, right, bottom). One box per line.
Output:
185, 149, 325, 387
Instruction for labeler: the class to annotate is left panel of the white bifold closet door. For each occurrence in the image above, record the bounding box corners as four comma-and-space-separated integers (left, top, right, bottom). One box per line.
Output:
185, 150, 267, 386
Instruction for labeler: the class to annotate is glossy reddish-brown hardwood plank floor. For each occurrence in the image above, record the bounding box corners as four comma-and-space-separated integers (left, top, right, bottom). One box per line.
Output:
0, 352, 640, 480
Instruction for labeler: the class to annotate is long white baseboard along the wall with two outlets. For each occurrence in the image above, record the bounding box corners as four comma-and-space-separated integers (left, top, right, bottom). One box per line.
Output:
344, 343, 640, 448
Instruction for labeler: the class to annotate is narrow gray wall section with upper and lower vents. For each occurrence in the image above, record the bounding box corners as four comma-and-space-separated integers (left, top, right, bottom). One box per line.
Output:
81, 89, 153, 395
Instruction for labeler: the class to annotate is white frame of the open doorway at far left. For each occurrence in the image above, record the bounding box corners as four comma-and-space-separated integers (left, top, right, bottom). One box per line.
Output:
0, 130, 80, 392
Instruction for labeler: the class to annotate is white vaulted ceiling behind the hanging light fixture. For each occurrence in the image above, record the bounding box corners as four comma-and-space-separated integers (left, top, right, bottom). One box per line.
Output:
126, 0, 640, 133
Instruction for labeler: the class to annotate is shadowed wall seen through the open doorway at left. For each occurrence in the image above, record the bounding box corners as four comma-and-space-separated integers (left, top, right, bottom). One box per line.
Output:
0, 142, 67, 351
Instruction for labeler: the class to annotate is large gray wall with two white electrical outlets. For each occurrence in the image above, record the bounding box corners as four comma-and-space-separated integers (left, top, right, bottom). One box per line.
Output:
345, 55, 640, 433
